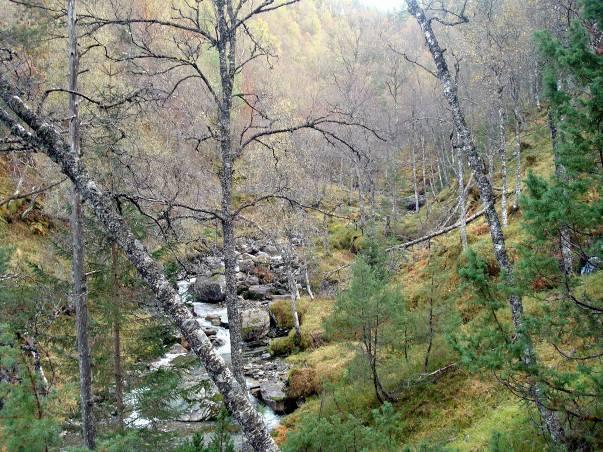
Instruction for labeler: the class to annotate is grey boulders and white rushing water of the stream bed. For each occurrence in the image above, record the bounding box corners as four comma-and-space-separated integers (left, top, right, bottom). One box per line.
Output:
142, 239, 310, 428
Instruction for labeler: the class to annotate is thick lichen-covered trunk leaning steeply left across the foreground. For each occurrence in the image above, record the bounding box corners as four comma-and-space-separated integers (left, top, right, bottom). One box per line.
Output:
0, 75, 279, 452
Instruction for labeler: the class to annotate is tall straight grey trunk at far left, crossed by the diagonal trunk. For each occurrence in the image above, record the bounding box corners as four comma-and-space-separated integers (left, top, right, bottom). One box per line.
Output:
67, 0, 95, 449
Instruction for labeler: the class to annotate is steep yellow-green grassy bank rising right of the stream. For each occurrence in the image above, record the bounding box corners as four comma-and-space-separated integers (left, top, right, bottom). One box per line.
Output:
278, 117, 601, 451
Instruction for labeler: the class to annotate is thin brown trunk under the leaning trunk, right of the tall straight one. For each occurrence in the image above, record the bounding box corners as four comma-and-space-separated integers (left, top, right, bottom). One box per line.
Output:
111, 243, 124, 430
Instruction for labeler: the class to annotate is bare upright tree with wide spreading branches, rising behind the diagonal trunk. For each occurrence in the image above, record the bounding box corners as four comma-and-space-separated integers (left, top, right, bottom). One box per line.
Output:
84, 0, 378, 387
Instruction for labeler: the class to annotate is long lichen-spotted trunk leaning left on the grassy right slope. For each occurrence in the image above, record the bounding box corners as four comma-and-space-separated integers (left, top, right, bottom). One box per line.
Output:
406, 0, 566, 443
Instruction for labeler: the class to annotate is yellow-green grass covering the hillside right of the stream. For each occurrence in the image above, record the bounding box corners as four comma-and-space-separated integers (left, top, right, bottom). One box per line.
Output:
277, 116, 580, 451
